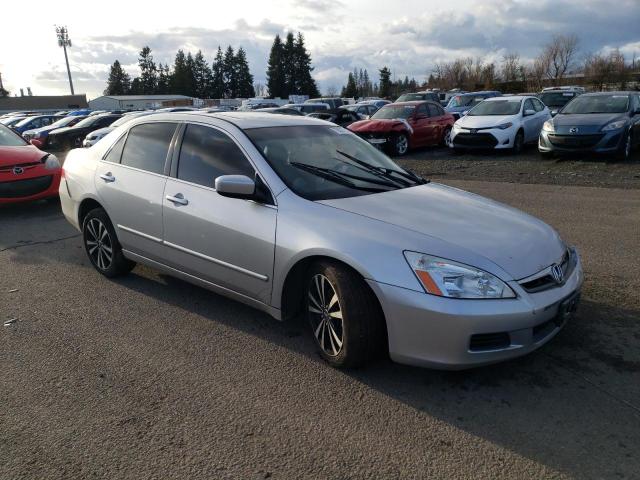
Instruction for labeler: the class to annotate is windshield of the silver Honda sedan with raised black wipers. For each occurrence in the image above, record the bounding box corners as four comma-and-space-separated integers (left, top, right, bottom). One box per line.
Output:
245, 125, 425, 200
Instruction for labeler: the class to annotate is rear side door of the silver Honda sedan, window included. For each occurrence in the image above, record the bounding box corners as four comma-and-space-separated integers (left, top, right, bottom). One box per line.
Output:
95, 122, 177, 261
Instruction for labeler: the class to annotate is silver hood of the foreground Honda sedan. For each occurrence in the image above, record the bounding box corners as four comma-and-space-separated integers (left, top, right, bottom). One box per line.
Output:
319, 183, 566, 280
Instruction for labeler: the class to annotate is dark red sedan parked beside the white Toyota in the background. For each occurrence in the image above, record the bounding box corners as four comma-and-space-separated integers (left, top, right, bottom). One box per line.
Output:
347, 102, 455, 156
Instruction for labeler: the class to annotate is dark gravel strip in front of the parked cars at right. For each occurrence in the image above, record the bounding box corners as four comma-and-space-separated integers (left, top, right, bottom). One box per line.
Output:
399, 146, 640, 189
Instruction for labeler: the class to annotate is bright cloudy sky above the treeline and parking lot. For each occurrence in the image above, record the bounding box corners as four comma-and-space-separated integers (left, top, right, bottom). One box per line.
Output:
0, 0, 640, 99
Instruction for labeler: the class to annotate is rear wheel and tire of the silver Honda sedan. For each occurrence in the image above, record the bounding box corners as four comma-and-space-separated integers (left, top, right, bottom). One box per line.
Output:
82, 208, 136, 278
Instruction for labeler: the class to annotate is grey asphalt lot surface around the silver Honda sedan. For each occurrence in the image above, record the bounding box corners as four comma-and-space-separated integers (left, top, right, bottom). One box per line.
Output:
0, 148, 640, 479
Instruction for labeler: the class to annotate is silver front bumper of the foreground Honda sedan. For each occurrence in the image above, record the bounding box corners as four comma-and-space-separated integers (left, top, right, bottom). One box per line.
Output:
368, 249, 583, 370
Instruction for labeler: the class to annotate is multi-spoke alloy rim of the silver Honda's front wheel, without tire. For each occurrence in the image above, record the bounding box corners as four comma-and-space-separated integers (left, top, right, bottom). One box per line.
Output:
307, 274, 344, 357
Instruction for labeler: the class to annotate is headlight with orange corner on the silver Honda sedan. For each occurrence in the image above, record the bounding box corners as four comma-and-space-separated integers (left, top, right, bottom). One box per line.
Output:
404, 252, 516, 299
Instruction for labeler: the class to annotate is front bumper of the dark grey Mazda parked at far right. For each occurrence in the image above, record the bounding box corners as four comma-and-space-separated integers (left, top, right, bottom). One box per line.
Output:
538, 128, 626, 153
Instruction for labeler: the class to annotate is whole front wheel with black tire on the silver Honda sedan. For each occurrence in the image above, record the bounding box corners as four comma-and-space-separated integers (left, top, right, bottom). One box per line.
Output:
305, 261, 385, 368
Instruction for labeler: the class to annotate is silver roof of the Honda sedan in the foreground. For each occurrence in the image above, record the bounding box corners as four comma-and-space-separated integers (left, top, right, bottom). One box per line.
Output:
139, 111, 327, 130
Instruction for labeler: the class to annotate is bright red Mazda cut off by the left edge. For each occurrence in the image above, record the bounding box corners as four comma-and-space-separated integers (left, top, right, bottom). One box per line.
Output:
0, 125, 62, 205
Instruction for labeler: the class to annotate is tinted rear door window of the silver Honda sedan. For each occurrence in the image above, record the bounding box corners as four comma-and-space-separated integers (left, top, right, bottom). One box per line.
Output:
121, 123, 176, 174
